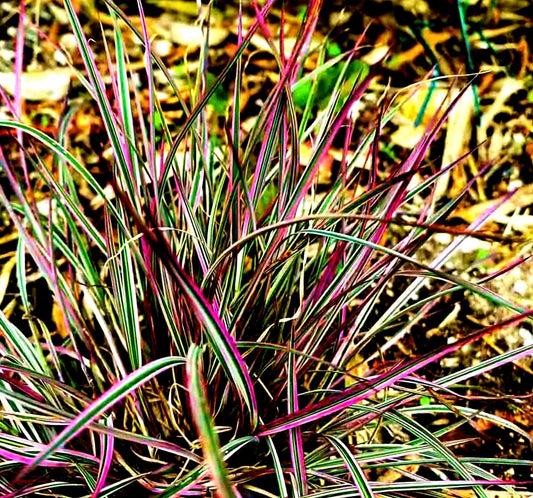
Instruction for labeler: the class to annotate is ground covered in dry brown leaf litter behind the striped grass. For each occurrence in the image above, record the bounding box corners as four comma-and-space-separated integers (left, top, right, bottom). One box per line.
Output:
0, 0, 533, 492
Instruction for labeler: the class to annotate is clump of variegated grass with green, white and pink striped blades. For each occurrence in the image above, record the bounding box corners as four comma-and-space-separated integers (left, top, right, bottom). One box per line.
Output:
0, 0, 532, 498
